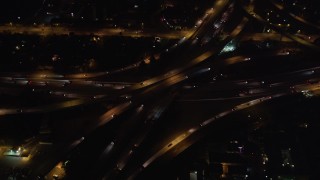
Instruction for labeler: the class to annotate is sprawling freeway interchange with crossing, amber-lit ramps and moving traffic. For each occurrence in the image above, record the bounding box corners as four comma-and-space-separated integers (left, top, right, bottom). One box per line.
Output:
0, 0, 320, 179
